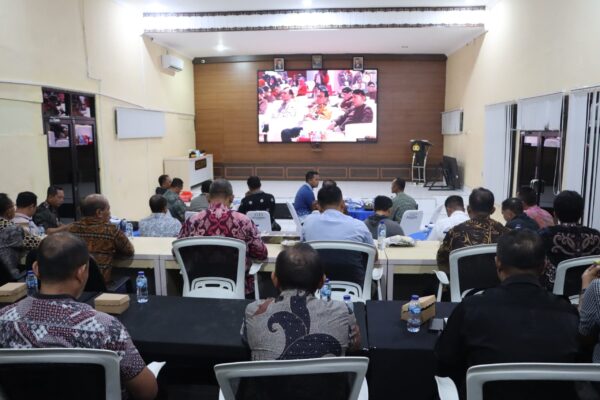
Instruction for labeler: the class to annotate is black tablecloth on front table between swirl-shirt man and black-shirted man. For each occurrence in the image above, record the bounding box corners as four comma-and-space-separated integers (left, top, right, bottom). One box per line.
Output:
367, 301, 456, 400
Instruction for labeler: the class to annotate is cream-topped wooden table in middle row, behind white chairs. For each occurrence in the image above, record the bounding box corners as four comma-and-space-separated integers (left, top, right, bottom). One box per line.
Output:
113, 237, 439, 300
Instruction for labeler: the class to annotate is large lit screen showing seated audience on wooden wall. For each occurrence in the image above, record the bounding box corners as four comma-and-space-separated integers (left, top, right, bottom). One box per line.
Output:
257, 69, 378, 143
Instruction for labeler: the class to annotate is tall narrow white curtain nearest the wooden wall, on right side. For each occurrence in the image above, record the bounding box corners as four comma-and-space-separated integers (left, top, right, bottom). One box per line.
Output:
483, 103, 512, 203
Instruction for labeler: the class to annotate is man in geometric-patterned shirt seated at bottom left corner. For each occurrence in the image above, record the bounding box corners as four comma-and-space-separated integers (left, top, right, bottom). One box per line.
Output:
0, 232, 158, 399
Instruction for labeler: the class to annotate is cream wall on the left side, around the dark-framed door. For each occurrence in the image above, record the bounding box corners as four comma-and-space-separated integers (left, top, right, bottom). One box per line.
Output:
0, 0, 195, 219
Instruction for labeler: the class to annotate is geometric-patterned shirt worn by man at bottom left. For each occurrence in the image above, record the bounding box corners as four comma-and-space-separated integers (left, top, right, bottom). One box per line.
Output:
0, 294, 146, 382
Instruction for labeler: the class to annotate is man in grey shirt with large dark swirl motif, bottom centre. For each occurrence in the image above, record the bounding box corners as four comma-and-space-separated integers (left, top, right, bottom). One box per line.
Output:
241, 243, 360, 360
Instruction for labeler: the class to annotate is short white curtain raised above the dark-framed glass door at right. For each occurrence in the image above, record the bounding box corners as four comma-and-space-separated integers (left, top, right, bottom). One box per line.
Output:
517, 93, 563, 131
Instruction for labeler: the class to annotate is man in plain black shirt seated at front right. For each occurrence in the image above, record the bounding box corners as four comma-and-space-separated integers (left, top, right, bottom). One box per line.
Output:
435, 229, 579, 400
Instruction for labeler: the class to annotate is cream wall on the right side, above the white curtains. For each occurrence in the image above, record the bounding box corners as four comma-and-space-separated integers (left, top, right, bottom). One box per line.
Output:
444, 0, 600, 187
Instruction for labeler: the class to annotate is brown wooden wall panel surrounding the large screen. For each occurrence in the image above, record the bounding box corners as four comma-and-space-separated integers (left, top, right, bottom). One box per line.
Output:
194, 55, 446, 179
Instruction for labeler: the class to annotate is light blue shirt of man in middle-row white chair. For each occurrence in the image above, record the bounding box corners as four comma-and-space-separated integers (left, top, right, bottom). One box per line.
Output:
302, 209, 374, 245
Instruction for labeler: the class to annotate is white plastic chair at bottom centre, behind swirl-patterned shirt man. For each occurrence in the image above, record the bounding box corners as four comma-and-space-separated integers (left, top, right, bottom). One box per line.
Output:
215, 357, 369, 400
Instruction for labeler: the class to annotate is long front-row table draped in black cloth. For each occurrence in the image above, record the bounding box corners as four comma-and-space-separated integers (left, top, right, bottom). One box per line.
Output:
88, 296, 455, 400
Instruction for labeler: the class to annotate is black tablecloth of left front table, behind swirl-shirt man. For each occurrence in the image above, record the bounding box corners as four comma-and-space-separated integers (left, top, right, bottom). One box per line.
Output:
112, 296, 369, 363
